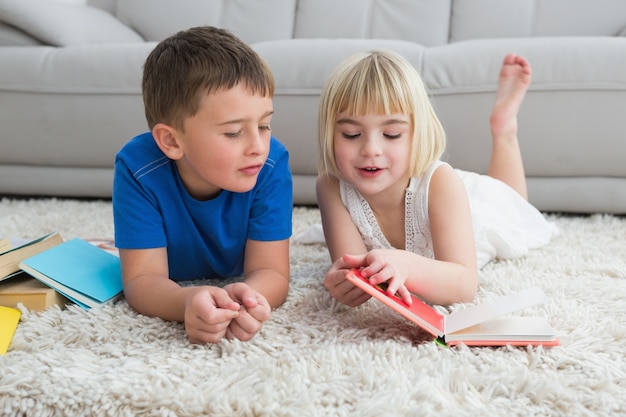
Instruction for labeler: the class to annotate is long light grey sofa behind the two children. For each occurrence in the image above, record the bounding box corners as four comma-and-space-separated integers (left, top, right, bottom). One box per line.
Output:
0, 0, 626, 213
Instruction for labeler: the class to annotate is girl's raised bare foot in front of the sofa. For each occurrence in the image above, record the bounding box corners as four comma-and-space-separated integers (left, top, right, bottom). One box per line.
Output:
489, 54, 532, 139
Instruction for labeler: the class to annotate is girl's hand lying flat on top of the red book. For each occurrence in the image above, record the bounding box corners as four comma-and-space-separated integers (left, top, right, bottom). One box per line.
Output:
344, 249, 413, 305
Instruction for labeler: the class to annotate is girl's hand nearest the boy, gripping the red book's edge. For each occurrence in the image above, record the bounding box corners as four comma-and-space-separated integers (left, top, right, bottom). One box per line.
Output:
324, 255, 370, 307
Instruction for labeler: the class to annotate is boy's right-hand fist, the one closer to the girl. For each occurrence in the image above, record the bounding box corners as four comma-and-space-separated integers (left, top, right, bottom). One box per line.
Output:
224, 282, 272, 341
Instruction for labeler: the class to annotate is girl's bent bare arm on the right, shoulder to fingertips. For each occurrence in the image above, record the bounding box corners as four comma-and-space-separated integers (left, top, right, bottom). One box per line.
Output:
361, 165, 478, 305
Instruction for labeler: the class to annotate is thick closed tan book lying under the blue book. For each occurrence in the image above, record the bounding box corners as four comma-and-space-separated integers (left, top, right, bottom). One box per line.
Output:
0, 273, 69, 311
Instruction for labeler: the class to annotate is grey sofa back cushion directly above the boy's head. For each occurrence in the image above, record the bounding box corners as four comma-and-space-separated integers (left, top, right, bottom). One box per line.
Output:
116, 0, 296, 43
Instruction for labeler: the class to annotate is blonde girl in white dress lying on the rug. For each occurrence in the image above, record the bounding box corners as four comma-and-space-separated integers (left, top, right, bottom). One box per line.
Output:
317, 51, 555, 306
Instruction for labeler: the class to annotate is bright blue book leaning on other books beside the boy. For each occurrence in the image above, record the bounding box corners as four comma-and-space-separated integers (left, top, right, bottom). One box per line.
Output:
20, 238, 122, 308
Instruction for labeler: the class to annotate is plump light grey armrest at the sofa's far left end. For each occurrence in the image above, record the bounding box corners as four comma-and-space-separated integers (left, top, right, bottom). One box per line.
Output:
0, 0, 144, 46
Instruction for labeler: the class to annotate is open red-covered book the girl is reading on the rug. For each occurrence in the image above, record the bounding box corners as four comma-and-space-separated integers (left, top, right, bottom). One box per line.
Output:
346, 270, 559, 346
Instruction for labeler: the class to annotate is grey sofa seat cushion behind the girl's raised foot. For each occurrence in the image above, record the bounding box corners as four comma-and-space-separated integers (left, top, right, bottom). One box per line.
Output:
423, 36, 626, 94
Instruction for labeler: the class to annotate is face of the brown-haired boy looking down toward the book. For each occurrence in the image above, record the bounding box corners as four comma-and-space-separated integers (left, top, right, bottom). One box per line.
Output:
176, 83, 273, 200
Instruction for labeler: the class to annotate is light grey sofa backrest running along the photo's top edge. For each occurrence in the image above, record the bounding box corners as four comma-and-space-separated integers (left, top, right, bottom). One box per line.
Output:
88, 0, 626, 47
